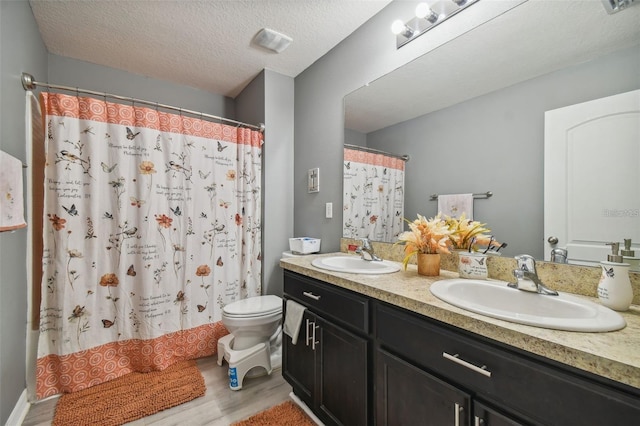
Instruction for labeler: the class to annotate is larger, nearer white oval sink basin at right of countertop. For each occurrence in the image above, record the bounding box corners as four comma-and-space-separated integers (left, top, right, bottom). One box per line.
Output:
430, 279, 627, 332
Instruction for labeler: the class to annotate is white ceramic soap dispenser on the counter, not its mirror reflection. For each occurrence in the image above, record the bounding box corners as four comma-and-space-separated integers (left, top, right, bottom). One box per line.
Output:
598, 243, 633, 311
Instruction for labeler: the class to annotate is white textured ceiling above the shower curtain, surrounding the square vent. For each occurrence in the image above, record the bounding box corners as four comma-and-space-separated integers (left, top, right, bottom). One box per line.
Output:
29, 0, 391, 97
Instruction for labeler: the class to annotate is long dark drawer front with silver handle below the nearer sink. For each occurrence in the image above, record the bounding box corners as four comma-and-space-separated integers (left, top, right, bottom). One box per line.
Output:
375, 304, 640, 425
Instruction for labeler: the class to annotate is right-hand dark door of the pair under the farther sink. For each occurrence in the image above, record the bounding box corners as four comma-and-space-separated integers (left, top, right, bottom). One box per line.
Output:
316, 319, 368, 426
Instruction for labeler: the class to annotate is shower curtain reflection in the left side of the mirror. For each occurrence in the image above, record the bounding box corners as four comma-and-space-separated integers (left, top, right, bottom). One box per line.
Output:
342, 148, 405, 242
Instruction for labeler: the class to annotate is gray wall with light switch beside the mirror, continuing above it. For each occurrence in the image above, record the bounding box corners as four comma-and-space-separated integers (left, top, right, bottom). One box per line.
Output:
293, 1, 517, 252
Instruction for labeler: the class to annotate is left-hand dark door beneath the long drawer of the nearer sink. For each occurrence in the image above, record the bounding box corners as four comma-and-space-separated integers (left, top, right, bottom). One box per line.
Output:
376, 349, 471, 426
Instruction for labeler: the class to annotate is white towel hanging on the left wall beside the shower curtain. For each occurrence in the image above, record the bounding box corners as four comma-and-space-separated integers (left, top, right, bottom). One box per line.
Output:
0, 151, 27, 231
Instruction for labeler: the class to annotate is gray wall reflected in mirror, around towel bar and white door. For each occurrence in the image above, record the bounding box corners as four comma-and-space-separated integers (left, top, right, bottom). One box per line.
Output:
367, 46, 640, 259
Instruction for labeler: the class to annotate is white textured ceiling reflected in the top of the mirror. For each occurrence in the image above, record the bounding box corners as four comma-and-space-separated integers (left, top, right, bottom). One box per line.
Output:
345, 0, 640, 133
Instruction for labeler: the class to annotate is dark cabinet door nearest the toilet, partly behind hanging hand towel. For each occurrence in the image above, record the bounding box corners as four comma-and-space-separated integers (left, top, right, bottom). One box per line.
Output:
282, 310, 317, 408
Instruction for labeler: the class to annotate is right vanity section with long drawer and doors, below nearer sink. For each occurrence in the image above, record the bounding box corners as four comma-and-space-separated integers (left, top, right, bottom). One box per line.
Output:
374, 303, 640, 426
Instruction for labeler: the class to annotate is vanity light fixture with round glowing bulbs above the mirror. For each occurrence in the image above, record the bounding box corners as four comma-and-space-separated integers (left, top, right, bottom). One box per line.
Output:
391, 0, 480, 49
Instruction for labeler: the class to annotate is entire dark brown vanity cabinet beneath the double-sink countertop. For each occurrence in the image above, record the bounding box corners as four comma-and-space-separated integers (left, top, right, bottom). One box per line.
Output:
283, 271, 640, 426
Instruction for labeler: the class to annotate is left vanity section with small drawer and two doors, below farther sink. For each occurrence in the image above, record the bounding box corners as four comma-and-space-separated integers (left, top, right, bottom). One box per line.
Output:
282, 271, 371, 426
